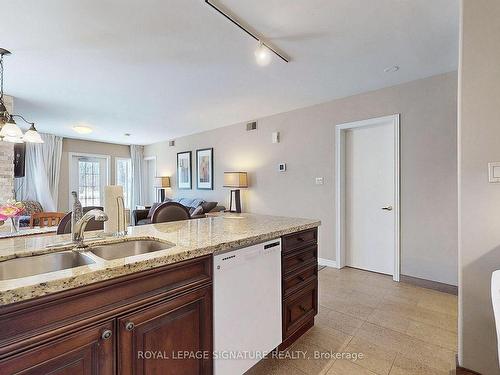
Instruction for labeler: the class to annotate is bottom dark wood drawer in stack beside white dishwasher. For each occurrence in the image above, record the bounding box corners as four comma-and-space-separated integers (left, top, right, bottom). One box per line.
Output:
283, 280, 318, 341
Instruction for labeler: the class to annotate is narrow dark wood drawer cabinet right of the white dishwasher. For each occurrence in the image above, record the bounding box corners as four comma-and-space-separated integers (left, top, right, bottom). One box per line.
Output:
279, 228, 318, 349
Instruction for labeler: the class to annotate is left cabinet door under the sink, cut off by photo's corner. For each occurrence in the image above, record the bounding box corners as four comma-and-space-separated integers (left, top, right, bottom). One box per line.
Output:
0, 322, 116, 375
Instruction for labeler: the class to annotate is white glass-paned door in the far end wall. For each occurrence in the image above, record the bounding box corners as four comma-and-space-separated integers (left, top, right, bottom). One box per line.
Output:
69, 154, 109, 209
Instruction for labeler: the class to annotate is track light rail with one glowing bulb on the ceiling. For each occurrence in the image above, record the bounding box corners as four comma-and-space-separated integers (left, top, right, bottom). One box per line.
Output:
205, 0, 290, 66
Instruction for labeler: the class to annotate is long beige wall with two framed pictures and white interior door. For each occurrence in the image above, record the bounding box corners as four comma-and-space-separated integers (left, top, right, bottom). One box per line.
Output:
145, 72, 457, 285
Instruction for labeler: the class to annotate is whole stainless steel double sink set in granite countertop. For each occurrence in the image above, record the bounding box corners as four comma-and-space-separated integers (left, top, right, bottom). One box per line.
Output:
0, 240, 174, 281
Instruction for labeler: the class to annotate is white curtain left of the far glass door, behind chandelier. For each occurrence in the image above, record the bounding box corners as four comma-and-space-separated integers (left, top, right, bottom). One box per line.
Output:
15, 133, 62, 212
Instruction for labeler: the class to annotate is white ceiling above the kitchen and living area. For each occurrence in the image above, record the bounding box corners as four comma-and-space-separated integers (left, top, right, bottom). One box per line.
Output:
0, 0, 459, 144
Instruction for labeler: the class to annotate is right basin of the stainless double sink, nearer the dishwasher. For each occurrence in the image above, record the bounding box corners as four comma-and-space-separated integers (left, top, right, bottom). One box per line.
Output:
88, 240, 174, 260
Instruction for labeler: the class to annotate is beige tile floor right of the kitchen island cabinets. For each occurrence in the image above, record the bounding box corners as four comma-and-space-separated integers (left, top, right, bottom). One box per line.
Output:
246, 268, 457, 375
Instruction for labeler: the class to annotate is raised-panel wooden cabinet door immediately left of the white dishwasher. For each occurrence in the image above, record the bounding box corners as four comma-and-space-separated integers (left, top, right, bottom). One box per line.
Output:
118, 287, 212, 375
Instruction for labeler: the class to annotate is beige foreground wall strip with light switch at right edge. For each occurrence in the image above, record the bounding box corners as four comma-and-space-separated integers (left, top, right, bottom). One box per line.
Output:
459, 0, 500, 375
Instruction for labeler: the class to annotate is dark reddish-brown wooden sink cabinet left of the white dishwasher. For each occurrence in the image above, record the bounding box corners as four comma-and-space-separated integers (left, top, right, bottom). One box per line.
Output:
0, 256, 212, 375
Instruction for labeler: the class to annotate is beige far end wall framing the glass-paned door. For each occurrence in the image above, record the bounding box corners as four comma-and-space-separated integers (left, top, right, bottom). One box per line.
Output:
58, 138, 130, 211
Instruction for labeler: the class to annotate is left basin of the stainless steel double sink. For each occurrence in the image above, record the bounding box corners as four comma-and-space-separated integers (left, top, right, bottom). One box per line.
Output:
0, 251, 95, 280
